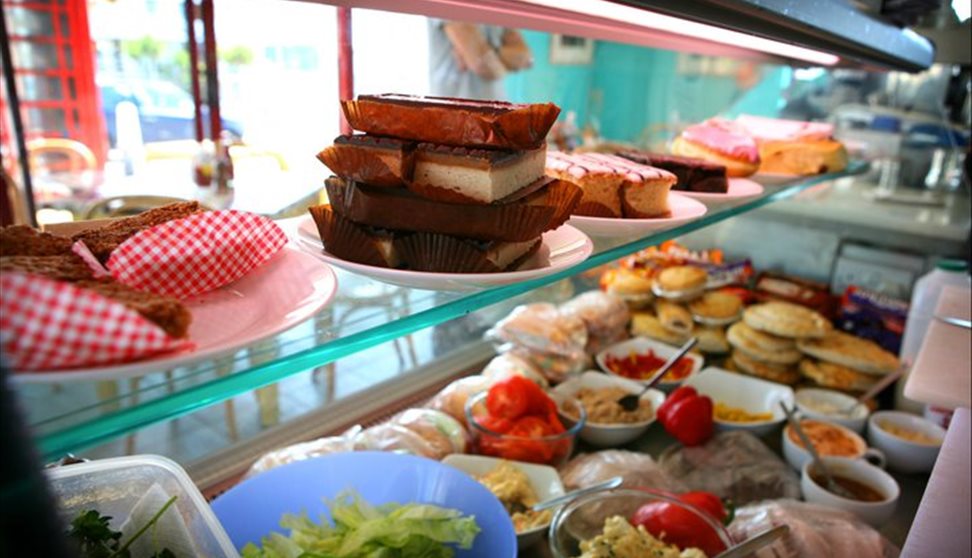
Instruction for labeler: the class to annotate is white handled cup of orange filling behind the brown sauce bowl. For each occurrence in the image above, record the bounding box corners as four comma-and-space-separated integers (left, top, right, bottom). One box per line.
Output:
783, 419, 884, 471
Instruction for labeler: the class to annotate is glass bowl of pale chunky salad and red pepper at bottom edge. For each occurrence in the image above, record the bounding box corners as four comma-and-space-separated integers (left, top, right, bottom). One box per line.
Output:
549, 488, 733, 558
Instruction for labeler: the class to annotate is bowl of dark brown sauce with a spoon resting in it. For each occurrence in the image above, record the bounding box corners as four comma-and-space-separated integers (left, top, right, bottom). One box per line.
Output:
800, 457, 901, 527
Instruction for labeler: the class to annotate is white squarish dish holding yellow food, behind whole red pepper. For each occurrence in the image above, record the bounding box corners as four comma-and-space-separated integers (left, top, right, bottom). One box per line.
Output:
683, 367, 793, 436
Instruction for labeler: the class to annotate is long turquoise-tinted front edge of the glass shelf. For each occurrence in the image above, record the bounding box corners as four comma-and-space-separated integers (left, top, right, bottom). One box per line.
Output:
38, 161, 869, 459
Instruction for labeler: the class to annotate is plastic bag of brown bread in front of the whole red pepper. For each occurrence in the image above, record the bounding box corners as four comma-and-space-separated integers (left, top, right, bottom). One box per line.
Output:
658, 430, 800, 505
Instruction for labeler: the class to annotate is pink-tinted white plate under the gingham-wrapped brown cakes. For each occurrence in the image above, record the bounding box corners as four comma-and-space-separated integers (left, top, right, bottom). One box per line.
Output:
13, 244, 337, 383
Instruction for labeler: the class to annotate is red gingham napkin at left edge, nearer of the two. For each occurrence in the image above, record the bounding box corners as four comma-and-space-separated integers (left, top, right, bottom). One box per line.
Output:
0, 273, 192, 370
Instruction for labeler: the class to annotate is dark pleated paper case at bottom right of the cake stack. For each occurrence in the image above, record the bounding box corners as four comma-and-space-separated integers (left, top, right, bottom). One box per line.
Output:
395, 233, 540, 273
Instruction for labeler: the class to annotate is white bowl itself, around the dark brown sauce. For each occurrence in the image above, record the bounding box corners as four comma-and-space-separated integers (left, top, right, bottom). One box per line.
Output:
800, 457, 901, 527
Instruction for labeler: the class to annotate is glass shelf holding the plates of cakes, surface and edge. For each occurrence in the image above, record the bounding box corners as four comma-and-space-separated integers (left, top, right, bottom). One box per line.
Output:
14, 162, 867, 459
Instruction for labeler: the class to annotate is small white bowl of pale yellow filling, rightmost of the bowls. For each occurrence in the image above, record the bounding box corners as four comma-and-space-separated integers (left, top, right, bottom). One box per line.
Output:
867, 411, 945, 473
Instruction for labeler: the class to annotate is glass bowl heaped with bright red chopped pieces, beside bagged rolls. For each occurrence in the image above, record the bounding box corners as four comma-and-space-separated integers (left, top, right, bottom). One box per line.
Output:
466, 376, 587, 467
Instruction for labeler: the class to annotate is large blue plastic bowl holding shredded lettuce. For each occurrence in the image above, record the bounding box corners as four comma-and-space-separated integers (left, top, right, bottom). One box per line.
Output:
213, 452, 516, 558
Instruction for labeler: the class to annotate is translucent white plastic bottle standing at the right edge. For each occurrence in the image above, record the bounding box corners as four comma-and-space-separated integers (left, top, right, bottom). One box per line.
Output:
894, 259, 970, 413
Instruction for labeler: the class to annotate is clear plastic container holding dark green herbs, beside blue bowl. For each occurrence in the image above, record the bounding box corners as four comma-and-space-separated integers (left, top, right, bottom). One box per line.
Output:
45, 455, 239, 558
